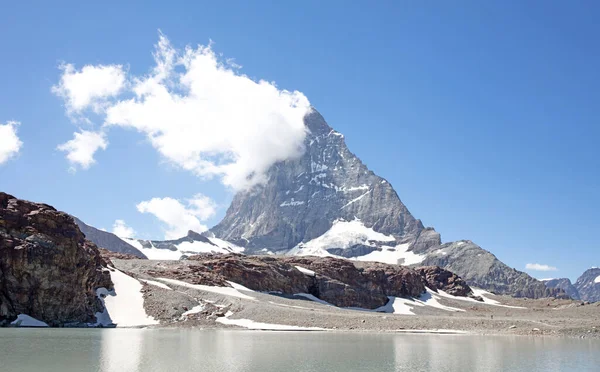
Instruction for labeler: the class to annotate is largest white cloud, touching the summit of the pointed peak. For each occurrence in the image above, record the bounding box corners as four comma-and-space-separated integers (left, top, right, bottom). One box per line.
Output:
54, 34, 310, 190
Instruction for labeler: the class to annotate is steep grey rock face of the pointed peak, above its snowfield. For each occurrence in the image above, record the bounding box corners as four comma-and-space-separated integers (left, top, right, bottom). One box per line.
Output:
211, 107, 424, 253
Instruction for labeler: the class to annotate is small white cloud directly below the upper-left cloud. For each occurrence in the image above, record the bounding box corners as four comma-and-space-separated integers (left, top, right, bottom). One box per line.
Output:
57, 130, 108, 169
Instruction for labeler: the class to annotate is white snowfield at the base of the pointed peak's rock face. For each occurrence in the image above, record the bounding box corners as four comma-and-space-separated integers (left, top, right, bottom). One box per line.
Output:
287, 219, 394, 257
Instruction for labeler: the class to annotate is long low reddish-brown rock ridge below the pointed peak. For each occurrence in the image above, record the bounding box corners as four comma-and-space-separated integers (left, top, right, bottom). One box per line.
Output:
127, 254, 473, 309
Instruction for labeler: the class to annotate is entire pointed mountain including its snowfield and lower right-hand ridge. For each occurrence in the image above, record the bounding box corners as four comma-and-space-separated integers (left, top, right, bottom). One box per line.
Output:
206, 110, 562, 298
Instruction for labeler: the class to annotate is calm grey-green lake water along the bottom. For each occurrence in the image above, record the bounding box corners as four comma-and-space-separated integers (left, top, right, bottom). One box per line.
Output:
0, 329, 600, 372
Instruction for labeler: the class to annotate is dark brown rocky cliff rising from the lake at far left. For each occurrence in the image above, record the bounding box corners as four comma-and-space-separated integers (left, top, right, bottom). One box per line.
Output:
0, 192, 113, 326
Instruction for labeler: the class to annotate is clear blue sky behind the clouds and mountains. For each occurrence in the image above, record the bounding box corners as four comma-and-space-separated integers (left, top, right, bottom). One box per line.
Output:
0, 1, 600, 279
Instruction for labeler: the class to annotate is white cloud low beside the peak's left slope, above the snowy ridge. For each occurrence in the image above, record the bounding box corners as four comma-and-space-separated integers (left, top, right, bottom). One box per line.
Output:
137, 194, 216, 239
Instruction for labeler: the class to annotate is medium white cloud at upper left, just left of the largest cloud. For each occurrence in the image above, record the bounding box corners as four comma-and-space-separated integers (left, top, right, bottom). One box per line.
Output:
52, 64, 126, 114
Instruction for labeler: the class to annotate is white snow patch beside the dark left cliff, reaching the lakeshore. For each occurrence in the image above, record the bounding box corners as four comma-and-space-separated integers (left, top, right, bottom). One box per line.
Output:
96, 269, 159, 327
